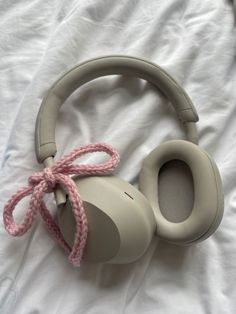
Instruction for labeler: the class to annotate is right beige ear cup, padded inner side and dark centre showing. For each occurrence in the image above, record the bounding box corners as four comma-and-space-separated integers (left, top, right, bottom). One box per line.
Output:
140, 140, 223, 245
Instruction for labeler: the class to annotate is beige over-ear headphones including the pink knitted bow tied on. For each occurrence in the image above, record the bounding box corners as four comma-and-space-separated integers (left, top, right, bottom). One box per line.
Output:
3, 56, 224, 265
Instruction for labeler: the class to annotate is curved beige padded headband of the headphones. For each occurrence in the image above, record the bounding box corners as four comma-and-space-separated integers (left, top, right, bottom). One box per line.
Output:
35, 56, 198, 162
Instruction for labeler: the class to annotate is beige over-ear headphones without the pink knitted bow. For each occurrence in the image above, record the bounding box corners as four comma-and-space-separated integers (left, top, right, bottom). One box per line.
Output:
35, 56, 224, 264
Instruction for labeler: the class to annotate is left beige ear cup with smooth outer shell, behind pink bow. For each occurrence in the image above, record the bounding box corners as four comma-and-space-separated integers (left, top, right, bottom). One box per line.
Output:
58, 176, 156, 264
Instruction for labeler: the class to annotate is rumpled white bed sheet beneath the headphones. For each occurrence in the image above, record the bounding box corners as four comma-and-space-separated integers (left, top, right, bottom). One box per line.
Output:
0, 0, 236, 314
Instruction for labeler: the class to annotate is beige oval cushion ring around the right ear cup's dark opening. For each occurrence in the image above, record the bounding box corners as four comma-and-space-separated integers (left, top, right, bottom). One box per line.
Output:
140, 140, 224, 245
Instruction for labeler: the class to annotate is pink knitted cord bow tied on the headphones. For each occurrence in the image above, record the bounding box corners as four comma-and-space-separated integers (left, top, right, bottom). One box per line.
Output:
3, 144, 119, 266
